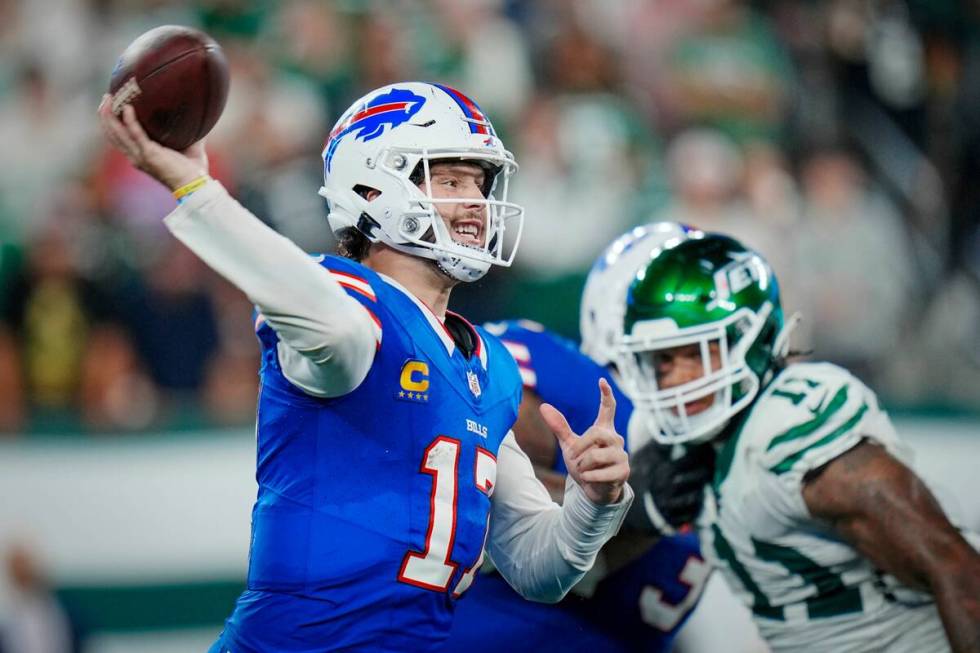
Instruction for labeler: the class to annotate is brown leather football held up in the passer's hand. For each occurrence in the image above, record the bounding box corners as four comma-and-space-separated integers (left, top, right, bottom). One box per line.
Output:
109, 25, 228, 150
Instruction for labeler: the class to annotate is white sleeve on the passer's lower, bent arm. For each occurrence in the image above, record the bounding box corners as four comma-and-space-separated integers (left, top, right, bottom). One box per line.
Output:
487, 432, 633, 603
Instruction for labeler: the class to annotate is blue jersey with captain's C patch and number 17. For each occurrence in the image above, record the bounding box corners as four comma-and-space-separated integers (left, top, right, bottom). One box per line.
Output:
213, 257, 521, 653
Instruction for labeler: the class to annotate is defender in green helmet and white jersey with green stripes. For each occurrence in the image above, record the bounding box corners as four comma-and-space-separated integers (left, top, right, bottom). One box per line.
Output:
619, 234, 980, 653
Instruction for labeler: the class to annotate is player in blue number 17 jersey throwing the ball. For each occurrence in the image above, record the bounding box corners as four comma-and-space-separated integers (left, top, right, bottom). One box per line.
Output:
100, 82, 632, 653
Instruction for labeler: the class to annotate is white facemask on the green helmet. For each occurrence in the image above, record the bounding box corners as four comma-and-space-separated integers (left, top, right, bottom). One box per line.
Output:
620, 302, 773, 445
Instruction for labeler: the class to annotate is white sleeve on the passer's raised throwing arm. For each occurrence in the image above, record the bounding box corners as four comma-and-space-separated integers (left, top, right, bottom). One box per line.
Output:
164, 180, 380, 397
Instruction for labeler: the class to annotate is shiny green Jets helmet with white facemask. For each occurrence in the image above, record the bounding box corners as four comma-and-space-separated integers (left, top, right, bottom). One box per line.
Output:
619, 234, 792, 444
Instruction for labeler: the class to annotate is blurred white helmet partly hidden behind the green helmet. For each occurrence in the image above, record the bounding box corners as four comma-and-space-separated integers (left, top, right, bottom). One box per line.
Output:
579, 222, 703, 365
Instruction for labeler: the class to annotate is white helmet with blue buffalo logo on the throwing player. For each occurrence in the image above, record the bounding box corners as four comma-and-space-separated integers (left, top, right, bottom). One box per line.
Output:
320, 82, 524, 281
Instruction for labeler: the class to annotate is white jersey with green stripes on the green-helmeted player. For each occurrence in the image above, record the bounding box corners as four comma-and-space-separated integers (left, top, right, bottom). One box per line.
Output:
699, 363, 949, 653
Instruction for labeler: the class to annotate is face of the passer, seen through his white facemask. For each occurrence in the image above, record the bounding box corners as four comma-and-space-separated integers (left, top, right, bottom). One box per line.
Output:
422, 161, 487, 247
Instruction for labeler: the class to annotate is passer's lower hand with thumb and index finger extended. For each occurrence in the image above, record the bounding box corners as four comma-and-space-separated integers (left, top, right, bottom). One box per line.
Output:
541, 379, 630, 504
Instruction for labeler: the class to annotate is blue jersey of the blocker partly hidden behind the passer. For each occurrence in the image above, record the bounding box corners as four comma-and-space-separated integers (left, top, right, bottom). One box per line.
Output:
445, 321, 710, 653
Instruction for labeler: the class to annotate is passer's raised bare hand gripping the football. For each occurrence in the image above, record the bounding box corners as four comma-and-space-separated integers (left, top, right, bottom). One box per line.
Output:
99, 95, 208, 190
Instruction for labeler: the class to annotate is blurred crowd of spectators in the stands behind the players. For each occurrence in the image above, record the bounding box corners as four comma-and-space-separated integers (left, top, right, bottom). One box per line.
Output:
0, 0, 980, 433
